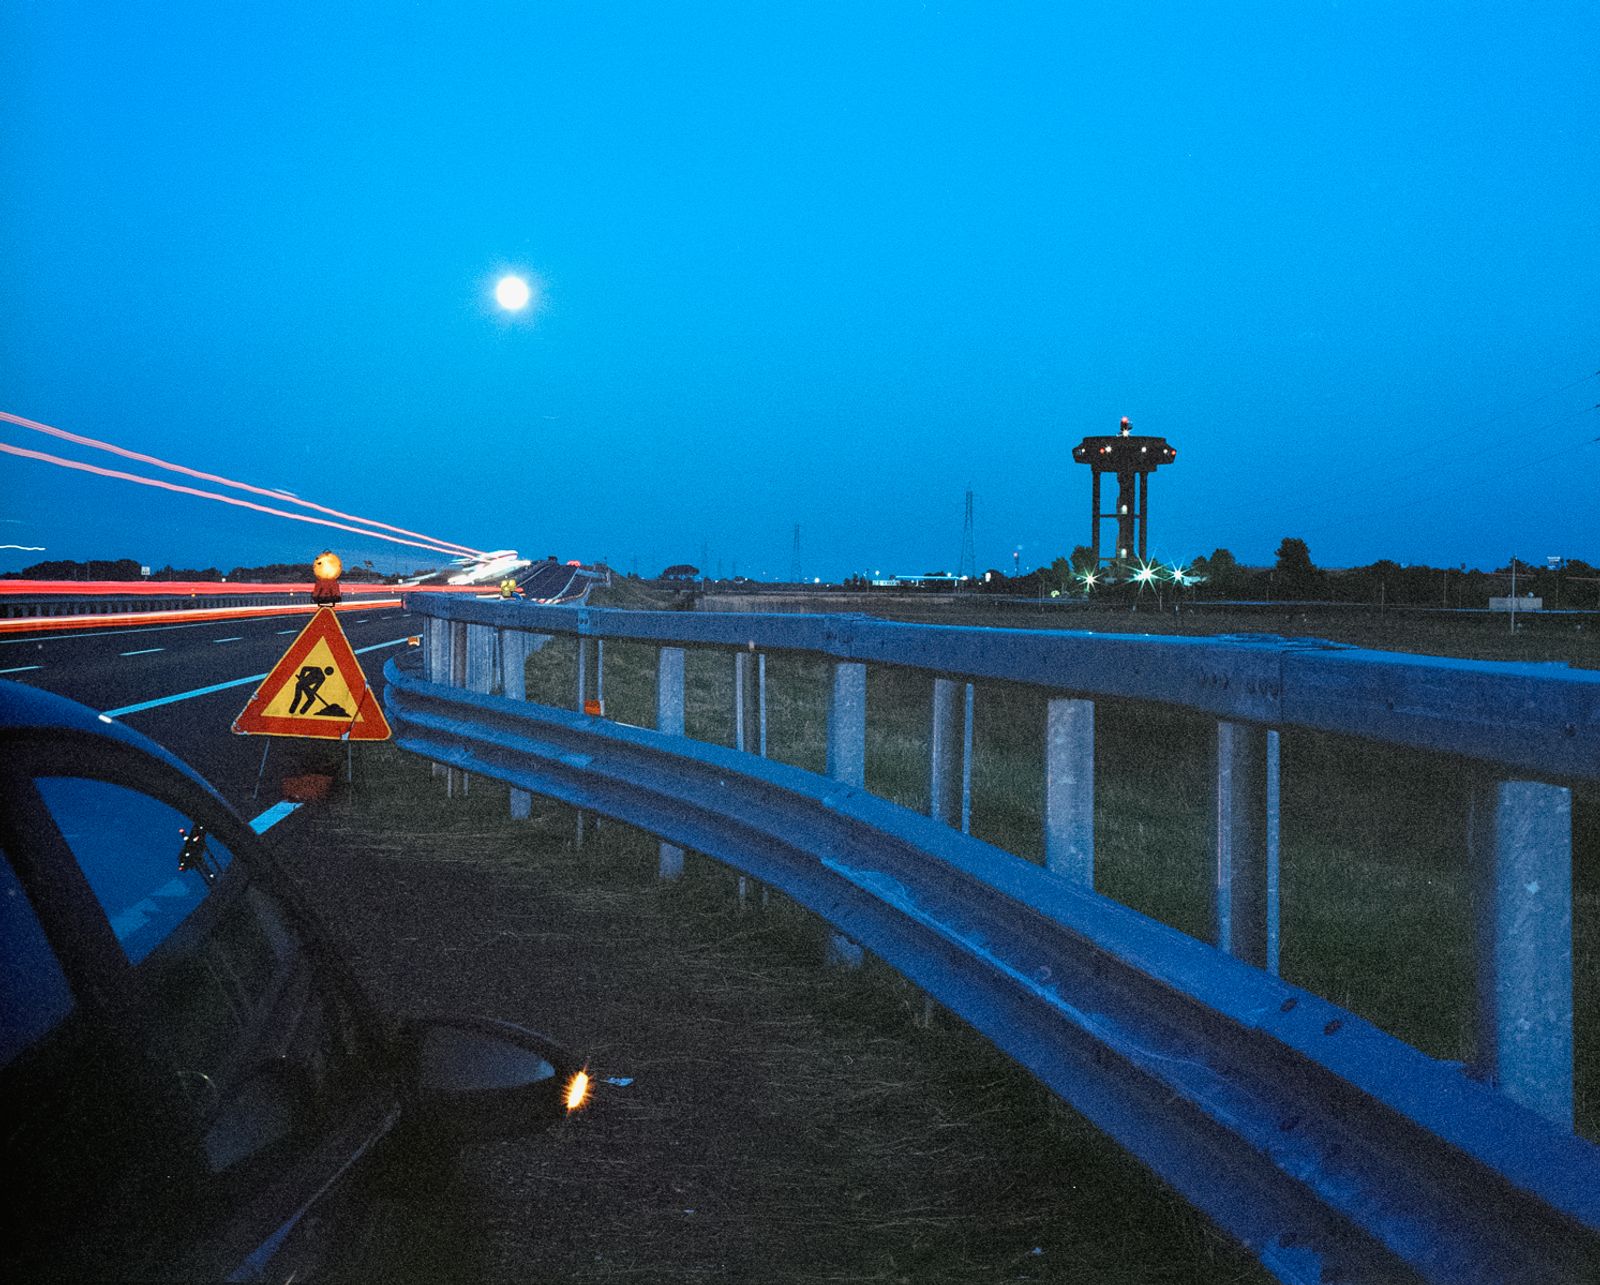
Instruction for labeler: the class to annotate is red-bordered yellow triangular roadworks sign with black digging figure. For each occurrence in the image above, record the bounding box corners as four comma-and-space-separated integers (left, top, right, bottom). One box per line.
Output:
234, 608, 389, 741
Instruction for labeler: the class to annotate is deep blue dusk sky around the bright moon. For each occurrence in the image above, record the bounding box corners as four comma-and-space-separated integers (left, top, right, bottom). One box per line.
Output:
0, 0, 1600, 578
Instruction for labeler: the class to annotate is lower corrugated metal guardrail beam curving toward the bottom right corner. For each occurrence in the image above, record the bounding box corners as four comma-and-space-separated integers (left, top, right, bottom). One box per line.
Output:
384, 662, 1600, 1285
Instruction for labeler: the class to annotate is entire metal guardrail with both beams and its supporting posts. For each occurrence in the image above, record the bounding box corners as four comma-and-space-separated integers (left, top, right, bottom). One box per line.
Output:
384, 598, 1600, 1285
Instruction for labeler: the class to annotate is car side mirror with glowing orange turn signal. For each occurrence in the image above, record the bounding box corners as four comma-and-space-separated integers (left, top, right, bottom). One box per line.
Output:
397, 1018, 589, 1143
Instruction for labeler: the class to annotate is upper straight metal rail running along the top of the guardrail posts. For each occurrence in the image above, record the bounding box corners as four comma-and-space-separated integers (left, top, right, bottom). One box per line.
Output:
406, 598, 1600, 781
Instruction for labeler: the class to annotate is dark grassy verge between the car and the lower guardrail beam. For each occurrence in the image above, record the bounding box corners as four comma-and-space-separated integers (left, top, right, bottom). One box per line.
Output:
274, 746, 1266, 1285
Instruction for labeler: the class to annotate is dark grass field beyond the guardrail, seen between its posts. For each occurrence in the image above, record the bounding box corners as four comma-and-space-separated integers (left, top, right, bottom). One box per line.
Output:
515, 586, 1600, 1138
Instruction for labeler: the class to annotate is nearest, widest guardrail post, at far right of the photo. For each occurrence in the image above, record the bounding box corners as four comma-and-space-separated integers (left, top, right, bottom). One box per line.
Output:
1470, 781, 1573, 1130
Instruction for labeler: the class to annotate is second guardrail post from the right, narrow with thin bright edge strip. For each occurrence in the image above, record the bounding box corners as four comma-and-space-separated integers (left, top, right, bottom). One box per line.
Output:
1214, 720, 1278, 968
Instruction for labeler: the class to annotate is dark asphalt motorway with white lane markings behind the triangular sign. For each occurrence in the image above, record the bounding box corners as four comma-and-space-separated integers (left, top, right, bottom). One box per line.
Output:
0, 606, 416, 816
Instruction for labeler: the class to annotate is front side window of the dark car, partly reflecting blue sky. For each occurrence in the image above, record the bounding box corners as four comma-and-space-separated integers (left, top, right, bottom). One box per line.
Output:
35, 776, 372, 1196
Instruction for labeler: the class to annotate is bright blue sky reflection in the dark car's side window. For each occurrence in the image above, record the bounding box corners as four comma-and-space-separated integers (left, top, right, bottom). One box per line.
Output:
35, 776, 232, 963
